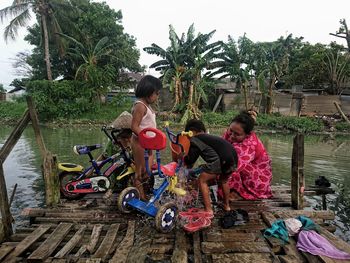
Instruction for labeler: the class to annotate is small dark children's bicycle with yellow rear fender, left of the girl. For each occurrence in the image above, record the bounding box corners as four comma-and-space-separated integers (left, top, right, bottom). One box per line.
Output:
58, 126, 135, 199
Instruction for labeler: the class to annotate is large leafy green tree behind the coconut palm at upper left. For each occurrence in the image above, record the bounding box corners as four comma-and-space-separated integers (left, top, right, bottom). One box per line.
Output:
25, 0, 142, 80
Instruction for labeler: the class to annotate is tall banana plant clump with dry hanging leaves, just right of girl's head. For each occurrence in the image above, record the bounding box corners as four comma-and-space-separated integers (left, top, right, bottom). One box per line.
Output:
144, 24, 221, 121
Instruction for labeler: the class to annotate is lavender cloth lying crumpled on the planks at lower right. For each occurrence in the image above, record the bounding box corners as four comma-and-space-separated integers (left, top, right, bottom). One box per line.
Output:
297, 230, 350, 259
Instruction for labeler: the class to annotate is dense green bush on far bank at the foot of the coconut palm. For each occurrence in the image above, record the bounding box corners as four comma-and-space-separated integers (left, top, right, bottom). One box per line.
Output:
27, 80, 97, 120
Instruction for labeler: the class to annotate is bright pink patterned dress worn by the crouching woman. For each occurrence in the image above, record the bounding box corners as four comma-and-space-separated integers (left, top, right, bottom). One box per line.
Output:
219, 131, 272, 200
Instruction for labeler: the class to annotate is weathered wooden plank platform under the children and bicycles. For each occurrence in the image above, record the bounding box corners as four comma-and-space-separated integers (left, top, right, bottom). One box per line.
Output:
0, 187, 350, 263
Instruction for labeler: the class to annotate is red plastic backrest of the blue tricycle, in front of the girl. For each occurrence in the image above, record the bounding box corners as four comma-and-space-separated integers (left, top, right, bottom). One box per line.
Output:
139, 128, 166, 150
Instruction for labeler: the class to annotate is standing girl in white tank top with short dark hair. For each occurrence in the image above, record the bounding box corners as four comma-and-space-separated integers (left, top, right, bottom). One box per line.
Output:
131, 75, 162, 200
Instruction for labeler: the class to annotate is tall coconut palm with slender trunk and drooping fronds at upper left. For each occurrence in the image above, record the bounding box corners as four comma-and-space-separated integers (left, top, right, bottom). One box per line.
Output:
0, 0, 71, 81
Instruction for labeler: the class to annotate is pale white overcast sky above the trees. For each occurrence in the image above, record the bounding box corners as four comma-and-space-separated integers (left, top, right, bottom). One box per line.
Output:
0, 0, 350, 88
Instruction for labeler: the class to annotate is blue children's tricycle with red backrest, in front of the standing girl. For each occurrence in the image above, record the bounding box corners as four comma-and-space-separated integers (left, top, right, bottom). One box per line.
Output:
118, 127, 192, 233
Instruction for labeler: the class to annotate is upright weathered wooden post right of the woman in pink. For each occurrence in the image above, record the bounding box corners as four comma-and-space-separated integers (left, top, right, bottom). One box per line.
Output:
291, 134, 305, 210
